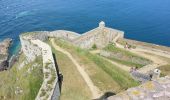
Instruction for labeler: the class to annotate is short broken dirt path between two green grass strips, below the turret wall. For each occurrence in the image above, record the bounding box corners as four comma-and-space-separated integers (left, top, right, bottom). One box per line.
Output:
90, 50, 131, 72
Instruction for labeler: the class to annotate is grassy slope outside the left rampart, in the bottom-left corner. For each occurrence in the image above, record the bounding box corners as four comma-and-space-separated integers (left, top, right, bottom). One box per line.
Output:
0, 54, 43, 100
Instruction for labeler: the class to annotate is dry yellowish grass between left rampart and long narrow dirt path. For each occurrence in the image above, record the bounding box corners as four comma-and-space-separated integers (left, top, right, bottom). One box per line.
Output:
48, 43, 91, 100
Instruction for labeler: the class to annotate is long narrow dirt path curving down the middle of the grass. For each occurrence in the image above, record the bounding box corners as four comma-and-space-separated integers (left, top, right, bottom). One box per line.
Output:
50, 38, 100, 99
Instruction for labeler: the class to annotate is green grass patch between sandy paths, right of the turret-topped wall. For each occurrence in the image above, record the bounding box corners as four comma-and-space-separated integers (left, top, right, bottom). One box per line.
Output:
104, 44, 151, 68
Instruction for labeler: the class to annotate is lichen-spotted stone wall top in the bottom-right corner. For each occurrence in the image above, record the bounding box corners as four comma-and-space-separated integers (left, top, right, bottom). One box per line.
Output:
108, 76, 170, 100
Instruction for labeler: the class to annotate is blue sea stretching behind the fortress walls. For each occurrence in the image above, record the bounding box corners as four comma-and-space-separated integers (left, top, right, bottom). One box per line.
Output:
0, 0, 170, 53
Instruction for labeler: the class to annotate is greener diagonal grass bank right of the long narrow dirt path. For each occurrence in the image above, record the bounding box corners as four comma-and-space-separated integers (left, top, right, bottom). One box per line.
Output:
79, 47, 138, 90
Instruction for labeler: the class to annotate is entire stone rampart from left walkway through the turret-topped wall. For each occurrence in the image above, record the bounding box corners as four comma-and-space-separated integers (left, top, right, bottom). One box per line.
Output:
20, 22, 124, 100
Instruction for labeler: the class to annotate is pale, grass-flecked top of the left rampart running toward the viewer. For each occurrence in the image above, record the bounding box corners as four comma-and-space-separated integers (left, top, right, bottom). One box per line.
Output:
31, 39, 60, 100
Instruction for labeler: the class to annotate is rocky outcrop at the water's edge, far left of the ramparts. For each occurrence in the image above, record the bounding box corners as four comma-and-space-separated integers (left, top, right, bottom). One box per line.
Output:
0, 38, 12, 71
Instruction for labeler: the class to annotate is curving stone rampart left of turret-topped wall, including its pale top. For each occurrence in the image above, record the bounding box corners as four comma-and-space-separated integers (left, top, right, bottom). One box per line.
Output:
20, 30, 79, 100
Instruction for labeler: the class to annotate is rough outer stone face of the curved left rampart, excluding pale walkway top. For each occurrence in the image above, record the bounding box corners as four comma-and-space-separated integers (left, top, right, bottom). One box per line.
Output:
20, 30, 79, 62
